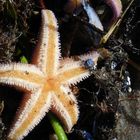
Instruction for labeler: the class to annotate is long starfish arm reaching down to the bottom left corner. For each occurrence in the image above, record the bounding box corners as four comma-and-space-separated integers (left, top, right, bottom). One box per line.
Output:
8, 89, 51, 140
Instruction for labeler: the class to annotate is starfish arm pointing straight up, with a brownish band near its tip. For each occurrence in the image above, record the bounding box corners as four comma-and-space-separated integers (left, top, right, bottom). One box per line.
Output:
32, 10, 60, 76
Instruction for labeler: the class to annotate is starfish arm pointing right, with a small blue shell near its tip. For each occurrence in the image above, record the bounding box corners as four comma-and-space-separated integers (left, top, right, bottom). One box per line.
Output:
59, 52, 99, 84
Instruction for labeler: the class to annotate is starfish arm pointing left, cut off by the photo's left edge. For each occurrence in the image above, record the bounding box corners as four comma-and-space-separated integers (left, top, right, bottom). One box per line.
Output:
0, 63, 43, 90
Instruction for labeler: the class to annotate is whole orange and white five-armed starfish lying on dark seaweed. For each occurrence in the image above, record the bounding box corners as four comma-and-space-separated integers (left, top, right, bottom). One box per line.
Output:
0, 10, 99, 140
